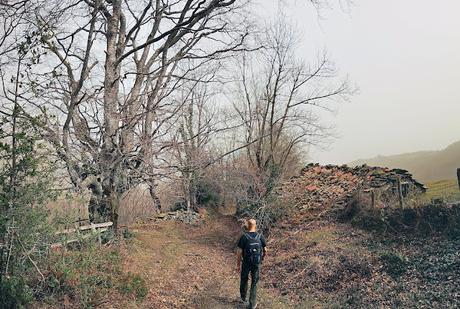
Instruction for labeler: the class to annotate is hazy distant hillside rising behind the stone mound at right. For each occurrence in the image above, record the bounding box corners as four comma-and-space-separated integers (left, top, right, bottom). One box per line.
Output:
349, 141, 460, 182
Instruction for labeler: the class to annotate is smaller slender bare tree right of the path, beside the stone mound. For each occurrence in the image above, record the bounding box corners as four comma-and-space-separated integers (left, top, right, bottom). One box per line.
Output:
233, 21, 353, 198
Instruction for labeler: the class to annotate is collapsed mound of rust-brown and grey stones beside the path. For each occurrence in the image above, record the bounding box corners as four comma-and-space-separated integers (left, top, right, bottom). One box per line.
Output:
278, 164, 426, 209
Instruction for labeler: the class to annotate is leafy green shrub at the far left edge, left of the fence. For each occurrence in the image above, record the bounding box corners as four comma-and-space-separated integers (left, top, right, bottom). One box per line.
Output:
0, 111, 55, 308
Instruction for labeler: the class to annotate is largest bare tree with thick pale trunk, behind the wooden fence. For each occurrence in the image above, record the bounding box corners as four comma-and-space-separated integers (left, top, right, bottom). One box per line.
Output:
0, 0, 249, 229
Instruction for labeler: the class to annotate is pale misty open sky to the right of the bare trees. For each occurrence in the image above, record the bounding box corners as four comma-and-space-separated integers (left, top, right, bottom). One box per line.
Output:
259, 0, 460, 163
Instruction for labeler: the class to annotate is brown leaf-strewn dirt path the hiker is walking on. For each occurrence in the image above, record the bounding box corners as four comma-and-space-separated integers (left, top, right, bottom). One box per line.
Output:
112, 215, 289, 309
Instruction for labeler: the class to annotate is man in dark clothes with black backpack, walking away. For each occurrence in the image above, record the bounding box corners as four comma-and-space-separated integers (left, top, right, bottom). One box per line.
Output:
237, 219, 267, 309
